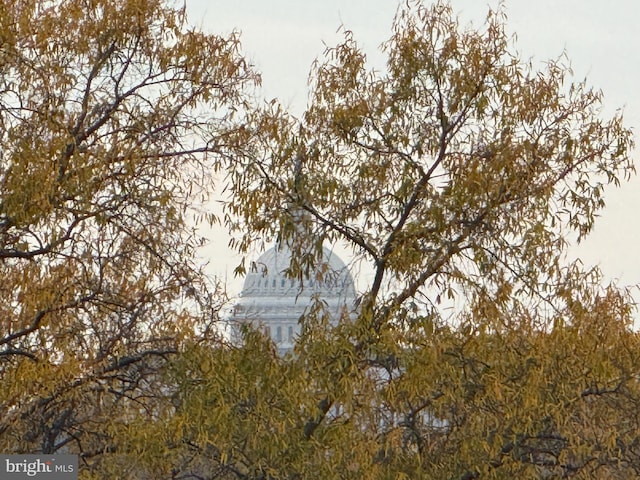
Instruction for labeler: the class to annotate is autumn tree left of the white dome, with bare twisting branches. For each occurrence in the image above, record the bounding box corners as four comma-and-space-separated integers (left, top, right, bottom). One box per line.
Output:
0, 0, 259, 478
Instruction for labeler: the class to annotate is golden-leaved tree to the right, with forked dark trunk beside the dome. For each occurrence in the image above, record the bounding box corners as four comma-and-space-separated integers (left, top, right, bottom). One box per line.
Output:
184, 2, 640, 480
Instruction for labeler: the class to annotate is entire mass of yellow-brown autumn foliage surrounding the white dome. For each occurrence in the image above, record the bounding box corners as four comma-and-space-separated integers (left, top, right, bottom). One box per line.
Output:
0, 0, 640, 480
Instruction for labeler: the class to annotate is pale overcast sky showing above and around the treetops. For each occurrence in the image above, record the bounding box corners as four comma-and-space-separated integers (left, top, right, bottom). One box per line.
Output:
186, 0, 640, 299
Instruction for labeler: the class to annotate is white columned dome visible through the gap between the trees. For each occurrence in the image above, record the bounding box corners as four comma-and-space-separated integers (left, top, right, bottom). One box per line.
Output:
232, 246, 355, 354
